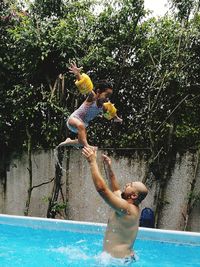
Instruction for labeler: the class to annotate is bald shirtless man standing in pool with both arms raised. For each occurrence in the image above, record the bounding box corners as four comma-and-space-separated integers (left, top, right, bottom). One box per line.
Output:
82, 147, 148, 258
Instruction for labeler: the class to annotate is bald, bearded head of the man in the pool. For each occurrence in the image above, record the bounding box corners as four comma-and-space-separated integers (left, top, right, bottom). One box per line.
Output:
122, 182, 148, 206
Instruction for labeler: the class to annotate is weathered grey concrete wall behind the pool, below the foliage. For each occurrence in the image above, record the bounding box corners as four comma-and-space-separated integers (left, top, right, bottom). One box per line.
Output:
0, 150, 200, 232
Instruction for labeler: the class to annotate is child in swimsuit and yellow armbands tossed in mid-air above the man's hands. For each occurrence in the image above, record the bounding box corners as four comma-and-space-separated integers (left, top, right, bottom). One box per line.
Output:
58, 63, 122, 151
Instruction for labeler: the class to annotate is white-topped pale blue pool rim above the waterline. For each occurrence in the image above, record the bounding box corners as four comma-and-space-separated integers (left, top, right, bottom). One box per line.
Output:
0, 214, 200, 246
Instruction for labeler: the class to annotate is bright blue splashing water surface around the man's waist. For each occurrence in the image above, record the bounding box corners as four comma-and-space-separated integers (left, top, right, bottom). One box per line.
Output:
0, 225, 200, 267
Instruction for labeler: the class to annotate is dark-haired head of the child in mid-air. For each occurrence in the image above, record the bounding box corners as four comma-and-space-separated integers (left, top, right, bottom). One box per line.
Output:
95, 80, 113, 99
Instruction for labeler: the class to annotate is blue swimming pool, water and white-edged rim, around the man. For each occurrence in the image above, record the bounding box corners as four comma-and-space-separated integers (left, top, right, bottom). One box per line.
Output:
0, 215, 200, 267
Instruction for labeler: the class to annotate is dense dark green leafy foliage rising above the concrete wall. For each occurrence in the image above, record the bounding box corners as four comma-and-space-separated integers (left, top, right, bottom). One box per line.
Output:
0, 0, 200, 159
